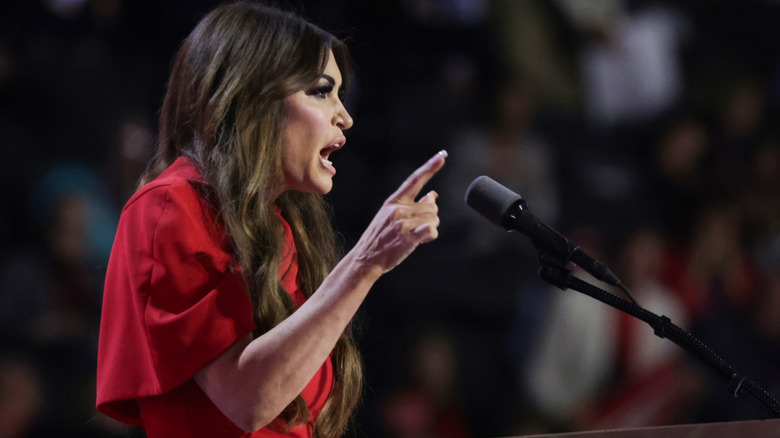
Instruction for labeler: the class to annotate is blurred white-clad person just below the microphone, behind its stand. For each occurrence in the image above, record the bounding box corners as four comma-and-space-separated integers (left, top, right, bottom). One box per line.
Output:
520, 229, 619, 433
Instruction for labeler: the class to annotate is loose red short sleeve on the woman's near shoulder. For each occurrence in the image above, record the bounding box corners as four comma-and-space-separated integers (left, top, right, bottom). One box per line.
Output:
97, 162, 254, 425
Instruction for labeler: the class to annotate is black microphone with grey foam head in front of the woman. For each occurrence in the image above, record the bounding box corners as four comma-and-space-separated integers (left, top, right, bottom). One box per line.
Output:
466, 175, 622, 286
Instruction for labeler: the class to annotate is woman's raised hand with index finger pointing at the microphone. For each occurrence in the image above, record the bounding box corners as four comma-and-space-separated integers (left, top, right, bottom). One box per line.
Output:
352, 151, 447, 273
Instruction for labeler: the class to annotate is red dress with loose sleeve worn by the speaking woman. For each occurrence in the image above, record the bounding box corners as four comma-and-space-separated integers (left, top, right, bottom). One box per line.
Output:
97, 158, 333, 438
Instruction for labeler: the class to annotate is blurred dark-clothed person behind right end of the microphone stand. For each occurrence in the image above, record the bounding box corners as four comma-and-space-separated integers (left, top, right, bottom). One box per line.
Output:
663, 199, 775, 422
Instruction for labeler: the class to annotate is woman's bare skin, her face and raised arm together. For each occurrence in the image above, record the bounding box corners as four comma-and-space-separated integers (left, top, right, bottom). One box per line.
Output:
195, 51, 447, 431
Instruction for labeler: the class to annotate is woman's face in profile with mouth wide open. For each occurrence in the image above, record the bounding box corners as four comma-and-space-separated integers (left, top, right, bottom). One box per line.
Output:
282, 53, 352, 194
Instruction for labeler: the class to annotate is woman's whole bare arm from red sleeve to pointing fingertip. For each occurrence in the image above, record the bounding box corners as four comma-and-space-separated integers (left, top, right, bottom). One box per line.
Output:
195, 151, 446, 430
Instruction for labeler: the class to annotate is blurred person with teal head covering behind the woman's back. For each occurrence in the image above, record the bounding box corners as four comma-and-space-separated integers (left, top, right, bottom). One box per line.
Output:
0, 163, 117, 431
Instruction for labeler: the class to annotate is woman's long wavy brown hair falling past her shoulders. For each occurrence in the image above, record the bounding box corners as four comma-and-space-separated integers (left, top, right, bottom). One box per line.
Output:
141, 2, 362, 437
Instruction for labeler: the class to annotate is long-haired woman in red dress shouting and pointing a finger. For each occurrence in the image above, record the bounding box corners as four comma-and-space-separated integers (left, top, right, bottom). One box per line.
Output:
97, 2, 446, 438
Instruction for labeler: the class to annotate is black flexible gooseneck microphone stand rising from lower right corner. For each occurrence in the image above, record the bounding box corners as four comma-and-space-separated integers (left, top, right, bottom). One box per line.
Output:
538, 251, 780, 418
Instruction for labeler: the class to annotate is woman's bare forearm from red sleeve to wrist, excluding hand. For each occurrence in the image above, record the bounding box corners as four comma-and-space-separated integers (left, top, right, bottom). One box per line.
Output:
196, 252, 381, 430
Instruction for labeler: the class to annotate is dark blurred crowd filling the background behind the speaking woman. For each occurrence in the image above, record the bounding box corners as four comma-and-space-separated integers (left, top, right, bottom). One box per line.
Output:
0, 0, 780, 438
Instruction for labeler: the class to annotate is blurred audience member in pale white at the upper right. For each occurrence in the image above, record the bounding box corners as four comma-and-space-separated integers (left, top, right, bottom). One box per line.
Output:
557, 0, 690, 127
